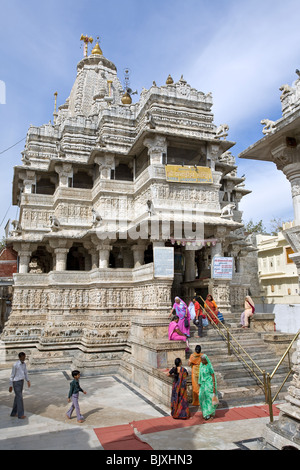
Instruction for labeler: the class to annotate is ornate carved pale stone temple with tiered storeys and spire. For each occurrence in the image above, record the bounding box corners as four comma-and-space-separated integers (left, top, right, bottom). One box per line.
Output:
2, 36, 251, 386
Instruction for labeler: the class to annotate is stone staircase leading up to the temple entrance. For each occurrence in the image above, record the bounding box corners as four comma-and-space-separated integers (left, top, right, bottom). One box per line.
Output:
184, 312, 292, 408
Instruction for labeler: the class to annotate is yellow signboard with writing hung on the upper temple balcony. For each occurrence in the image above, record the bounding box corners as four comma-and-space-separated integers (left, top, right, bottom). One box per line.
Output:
166, 165, 213, 184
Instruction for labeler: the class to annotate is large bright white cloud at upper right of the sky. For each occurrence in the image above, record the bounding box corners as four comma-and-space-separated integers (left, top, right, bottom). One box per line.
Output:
188, 0, 300, 125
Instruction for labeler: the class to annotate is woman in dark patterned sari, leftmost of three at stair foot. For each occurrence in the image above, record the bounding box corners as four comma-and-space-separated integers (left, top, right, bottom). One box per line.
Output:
169, 357, 190, 419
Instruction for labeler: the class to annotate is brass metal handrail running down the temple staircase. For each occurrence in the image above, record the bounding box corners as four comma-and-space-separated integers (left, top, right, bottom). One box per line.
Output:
199, 296, 300, 422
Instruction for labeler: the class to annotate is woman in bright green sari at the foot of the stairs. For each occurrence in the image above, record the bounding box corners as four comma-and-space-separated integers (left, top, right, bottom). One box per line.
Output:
199, 354, 218, 420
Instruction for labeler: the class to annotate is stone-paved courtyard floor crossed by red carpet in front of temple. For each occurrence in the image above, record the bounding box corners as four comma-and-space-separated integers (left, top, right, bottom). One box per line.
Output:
0, 369, 276, 451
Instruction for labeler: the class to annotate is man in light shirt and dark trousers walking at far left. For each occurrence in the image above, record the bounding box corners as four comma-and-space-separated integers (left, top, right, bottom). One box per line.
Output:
9, 352, 30, 419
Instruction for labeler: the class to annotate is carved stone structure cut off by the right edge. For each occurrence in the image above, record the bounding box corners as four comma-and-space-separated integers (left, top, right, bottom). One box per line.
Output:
240, 75, 300, 450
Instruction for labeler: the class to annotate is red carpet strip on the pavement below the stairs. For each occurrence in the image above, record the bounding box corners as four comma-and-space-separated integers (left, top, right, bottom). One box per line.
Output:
94, 405, 279, 450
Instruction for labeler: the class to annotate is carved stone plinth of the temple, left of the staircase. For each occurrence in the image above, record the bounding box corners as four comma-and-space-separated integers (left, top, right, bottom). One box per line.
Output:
2, 264, 172, 368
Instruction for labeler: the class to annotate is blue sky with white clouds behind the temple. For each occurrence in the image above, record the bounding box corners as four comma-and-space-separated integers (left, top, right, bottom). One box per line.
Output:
0, 0, 300, 237
